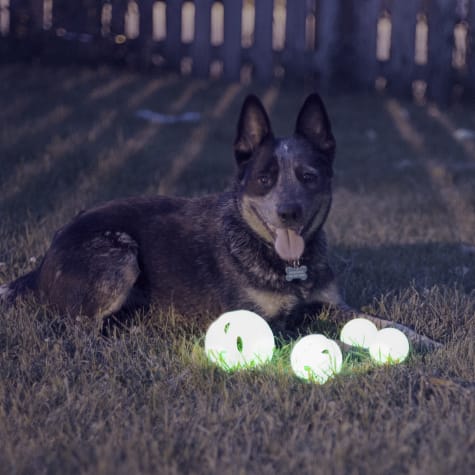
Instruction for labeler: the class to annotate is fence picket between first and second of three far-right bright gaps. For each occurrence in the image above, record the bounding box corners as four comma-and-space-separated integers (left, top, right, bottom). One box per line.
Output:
387, 0, 420, 97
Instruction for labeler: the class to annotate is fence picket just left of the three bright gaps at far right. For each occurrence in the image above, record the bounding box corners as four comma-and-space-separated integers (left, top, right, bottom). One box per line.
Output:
352, 0, 382, 89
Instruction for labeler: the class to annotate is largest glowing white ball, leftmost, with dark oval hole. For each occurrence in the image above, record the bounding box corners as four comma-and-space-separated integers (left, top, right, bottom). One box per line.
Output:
205, 310, 275, 370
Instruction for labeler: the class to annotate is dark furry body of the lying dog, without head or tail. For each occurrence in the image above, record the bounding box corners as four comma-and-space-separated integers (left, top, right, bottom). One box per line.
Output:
4, 193, 336, 326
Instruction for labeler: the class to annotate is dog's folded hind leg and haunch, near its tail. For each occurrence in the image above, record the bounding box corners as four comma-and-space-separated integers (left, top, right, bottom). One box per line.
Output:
37, 231, 140, 325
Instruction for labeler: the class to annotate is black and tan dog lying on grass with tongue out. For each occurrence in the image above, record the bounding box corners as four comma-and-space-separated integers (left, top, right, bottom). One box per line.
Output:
0, 94, 442, 348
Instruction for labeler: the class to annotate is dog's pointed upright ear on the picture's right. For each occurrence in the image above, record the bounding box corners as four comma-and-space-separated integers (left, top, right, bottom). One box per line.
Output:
295, 93, 336, 158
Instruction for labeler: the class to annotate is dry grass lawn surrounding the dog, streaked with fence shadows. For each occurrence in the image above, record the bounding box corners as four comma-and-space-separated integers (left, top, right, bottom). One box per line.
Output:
0, 65, 475, 474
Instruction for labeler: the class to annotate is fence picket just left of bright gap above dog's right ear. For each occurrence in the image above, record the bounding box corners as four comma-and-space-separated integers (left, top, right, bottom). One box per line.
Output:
284, 0, 307, 77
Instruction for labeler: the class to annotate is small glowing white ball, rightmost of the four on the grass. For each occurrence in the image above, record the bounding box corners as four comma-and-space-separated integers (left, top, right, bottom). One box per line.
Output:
369, 328, 410, 364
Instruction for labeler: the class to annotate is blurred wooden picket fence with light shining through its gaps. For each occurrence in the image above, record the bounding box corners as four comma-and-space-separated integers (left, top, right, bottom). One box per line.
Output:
0, 0, 475, 101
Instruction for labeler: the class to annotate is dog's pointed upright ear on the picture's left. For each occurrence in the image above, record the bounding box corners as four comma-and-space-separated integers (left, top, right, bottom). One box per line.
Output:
234, 94, 272, 166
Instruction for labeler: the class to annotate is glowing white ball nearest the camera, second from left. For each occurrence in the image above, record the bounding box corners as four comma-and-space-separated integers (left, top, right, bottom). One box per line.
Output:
290, 335, 343, 384
